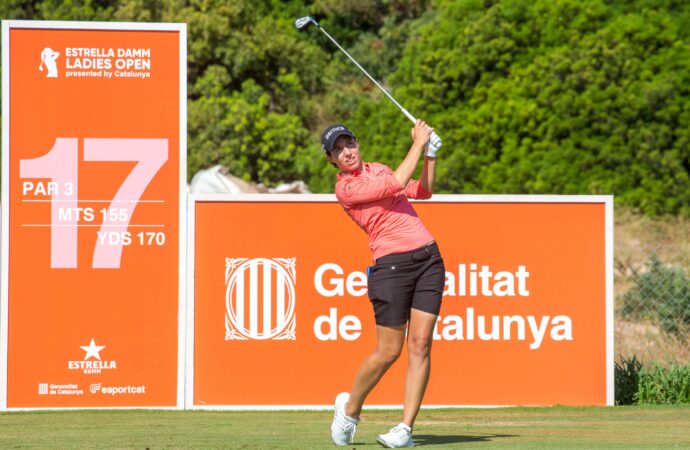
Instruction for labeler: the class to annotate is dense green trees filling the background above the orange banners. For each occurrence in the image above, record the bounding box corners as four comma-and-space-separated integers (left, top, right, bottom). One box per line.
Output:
0, 0, 690, 215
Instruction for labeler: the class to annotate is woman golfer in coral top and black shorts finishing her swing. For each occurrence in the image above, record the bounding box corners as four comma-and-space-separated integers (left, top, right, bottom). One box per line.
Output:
321, 120, 445, 448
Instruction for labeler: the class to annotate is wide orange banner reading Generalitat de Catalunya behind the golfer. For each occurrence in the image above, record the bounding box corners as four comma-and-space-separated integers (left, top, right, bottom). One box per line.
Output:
187, 195, 613, 408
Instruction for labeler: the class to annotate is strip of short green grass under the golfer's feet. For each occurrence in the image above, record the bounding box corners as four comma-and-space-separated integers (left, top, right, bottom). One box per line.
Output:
0, 406, 690, 449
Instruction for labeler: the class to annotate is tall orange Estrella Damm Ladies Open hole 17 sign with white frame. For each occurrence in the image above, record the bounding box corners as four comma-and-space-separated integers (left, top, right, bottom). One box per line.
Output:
0, 21, 186, 408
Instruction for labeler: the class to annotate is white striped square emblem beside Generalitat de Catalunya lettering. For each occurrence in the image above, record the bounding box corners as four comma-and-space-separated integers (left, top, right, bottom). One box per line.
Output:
225, 258, 296, 341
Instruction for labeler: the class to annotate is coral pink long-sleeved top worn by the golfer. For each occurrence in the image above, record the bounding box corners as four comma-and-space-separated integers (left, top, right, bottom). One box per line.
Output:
335, 163, 434, 260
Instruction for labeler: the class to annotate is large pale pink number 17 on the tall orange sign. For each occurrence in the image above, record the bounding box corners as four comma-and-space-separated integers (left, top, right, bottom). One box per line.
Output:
19, 138, 168, 269
